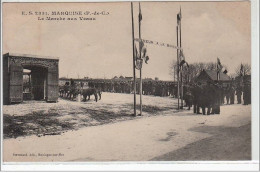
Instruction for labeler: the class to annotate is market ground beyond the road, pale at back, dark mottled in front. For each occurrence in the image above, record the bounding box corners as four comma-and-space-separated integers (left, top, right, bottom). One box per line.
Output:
3, 93, 176, 138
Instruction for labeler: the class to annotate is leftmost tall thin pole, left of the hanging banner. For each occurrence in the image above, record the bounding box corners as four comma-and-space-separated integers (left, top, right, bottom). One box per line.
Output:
131, 2, 136, 116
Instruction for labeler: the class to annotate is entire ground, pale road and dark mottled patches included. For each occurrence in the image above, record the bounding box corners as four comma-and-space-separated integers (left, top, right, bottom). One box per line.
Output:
3, 93, 251, 162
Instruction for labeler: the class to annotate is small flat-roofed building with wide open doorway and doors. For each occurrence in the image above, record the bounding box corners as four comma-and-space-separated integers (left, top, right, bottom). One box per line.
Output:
3, 53, 59, 104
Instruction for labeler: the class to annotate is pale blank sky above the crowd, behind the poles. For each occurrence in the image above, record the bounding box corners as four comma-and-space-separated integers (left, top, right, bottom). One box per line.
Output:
3, 1, 251, 80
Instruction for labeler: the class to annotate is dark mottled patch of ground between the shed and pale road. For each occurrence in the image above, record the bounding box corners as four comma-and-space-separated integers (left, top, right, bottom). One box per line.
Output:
3, 104, 178, 139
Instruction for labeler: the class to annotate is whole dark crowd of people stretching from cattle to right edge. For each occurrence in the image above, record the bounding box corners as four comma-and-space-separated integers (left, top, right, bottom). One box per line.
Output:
60, 79, 251, 115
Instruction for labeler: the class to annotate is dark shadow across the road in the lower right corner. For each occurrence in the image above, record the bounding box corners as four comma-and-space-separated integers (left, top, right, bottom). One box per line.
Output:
152, 123, 251, 161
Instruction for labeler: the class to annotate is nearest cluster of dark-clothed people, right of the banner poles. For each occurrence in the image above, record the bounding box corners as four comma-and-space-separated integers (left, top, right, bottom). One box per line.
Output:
183, 81, 251, 115
